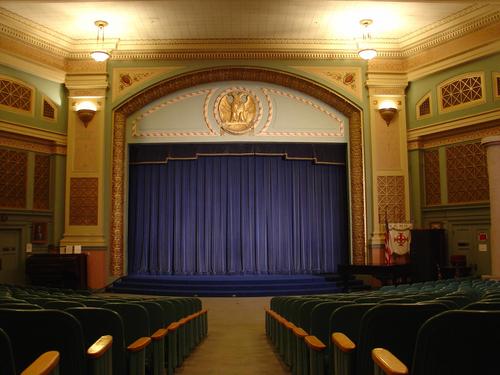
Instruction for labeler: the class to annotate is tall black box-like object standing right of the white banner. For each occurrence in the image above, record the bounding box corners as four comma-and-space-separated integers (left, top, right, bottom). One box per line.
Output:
410, 229, 447, 282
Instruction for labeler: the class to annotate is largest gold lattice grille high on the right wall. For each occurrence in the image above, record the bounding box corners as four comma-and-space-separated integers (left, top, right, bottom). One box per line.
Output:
438, 73, 485, 112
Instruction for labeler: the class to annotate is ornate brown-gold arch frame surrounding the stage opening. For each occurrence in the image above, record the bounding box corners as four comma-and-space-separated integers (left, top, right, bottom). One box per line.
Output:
110, 67, 366, 276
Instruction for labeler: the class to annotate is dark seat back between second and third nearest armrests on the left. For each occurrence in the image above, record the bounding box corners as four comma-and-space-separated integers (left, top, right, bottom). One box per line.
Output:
65, 307, 127, 375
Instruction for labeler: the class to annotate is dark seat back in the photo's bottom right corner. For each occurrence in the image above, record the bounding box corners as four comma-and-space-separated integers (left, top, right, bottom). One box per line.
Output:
411, 310, 500, 375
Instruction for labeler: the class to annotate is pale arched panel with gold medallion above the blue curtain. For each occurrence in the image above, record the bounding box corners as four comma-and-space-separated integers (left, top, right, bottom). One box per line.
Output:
127, 81, 349, 143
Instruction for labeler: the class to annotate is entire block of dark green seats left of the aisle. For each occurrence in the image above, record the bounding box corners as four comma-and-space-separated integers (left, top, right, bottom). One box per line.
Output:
0, 285, 208, 375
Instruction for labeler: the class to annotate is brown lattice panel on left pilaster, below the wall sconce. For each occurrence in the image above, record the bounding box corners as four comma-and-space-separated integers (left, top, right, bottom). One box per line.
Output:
69, 177, 99, 225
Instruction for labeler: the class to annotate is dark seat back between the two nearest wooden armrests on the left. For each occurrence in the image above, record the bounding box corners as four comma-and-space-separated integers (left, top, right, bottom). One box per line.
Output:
0, 309, 86, 375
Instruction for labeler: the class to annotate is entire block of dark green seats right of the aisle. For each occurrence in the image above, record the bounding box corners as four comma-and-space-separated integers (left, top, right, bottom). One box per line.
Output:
265, 278, 500, 375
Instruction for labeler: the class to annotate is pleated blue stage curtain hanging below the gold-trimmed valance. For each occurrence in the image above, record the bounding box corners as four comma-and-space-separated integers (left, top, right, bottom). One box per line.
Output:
128, 156, 348, 275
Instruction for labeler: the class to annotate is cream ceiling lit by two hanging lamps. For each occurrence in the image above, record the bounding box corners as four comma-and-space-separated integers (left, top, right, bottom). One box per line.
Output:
0, 0, 500, 58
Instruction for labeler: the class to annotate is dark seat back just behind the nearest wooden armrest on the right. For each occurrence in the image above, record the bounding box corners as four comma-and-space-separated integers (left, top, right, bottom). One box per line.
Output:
356, 303, 446, 375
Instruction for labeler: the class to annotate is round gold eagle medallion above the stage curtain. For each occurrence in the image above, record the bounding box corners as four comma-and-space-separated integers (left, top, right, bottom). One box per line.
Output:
214, 87, 262, 134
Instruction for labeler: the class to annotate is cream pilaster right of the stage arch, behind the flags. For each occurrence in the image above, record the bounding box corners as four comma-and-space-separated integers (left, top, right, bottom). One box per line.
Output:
366, 72, 410, 264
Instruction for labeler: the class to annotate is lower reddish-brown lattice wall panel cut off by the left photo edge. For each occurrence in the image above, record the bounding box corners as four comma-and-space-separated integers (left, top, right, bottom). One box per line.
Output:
0, 149, 28, 208
